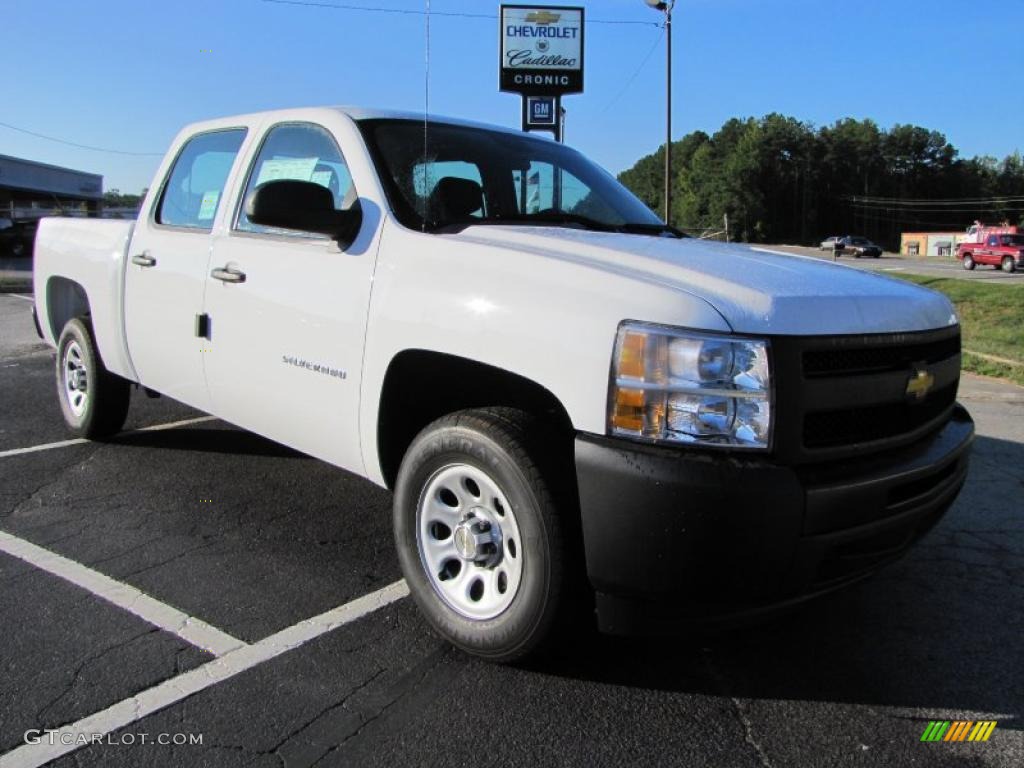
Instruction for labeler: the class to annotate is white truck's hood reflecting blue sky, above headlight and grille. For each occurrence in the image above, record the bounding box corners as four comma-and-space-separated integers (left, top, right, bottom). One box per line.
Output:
449, 225, 956, 335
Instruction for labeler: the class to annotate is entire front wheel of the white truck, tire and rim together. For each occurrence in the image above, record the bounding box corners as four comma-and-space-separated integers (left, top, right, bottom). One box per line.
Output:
394, 409, 564, 662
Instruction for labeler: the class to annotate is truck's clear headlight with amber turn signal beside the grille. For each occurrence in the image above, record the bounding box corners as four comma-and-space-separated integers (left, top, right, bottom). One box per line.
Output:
608, 323, 772, 449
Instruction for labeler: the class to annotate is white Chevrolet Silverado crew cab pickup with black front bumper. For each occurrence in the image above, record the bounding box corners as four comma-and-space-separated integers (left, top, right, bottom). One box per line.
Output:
35, 109, 974, 660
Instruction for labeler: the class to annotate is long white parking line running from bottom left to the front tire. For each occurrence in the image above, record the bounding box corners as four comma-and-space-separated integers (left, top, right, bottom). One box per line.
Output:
0, 582, 409, 768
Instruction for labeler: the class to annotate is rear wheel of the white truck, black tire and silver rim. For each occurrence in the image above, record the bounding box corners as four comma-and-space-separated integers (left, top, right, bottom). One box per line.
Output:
55, 317, 131, 439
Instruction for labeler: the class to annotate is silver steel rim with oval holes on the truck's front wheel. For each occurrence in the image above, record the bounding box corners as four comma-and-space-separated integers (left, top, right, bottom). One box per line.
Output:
416, 464, 524, 621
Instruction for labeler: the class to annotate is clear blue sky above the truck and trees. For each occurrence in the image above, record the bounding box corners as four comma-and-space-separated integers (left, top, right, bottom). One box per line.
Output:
0, 0, 1024, 191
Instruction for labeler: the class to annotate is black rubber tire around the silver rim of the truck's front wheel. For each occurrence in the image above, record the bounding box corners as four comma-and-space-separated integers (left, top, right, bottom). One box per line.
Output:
394, 409, 567, 663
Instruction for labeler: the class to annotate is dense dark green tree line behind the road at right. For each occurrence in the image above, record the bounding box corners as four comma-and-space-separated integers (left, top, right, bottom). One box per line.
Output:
618, 114, 1024, 249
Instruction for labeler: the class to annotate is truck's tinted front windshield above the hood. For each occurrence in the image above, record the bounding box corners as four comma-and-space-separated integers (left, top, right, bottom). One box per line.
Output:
359, 120, 667, 236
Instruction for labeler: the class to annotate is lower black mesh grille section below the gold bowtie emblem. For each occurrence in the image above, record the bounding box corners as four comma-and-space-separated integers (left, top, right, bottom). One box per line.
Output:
804, 384, 956, 449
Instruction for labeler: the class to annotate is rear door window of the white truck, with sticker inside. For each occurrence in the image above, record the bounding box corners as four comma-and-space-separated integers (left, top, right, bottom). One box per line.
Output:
157, 128, 246, 230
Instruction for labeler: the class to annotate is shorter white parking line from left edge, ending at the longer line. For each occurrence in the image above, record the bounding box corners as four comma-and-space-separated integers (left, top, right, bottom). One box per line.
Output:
0, 530, 246, 656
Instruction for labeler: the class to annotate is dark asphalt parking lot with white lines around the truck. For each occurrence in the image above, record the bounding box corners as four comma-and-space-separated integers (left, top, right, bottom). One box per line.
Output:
0, 290, 1024, 768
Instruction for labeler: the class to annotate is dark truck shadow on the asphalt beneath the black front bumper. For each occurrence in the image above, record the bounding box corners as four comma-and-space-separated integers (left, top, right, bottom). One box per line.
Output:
530, 437, 1024, 730
